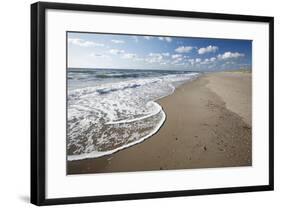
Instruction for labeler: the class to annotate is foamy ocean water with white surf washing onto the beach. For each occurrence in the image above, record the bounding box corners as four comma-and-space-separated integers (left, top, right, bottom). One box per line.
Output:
67, 68, 200, 161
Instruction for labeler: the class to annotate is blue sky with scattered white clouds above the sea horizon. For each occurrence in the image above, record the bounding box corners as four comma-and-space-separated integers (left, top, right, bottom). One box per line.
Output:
67, 32, 252, 71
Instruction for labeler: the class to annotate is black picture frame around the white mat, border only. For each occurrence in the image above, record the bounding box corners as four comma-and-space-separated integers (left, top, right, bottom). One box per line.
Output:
31, 2, 274, 205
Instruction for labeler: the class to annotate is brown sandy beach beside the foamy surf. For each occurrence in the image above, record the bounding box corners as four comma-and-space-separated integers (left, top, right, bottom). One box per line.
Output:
67, 71, 252, 174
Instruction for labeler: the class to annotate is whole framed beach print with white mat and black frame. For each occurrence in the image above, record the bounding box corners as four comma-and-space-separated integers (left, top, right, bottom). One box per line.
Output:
31, 2, 274, 205
